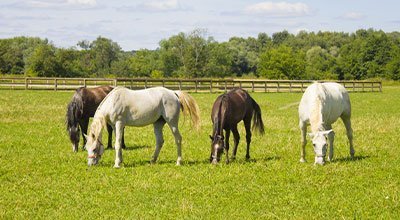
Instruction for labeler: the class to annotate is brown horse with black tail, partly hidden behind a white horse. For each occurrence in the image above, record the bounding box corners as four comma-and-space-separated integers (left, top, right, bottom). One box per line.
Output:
66, 86, 125, 152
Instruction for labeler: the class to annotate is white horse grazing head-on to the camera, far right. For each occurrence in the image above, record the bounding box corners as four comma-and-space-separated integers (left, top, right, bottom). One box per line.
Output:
299, 83, 354, 165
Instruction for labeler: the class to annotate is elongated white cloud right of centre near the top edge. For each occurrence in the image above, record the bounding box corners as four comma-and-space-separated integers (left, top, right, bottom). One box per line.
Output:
244, 2, 311, 17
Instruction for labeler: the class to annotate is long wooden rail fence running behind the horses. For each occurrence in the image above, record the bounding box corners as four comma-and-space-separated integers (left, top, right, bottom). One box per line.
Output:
0, 77, 382, 93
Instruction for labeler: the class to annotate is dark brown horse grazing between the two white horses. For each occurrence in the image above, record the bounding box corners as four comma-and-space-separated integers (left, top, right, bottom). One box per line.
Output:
210, 89, 264, 164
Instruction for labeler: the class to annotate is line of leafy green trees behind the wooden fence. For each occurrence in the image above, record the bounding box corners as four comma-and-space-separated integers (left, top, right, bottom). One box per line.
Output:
0, 29, 400, 80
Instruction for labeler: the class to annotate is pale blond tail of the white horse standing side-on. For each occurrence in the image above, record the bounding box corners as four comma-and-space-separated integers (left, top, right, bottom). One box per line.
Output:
175, 91, 200, 131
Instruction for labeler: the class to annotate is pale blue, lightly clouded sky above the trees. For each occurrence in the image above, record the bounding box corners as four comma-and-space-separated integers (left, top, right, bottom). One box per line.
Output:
0, 0, 400, 51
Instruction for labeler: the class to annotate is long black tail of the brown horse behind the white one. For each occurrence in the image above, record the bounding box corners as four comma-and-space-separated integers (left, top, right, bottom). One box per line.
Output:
65, 88, 83, 143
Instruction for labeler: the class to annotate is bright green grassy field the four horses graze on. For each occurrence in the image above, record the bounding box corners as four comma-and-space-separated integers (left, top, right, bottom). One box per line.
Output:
0, 85, 400, 219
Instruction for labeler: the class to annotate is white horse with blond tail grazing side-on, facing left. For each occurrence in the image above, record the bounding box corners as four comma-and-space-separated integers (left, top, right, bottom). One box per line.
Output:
86, 87, 200, 168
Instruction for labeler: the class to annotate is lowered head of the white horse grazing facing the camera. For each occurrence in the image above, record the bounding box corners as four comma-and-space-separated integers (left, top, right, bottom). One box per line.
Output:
309, 130, 333, 165
